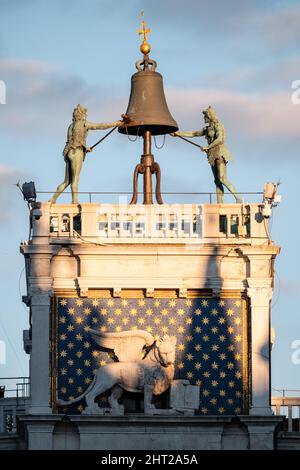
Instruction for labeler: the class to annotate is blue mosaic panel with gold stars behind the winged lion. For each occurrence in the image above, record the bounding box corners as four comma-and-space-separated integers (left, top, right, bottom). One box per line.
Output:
56, 298, 247, 415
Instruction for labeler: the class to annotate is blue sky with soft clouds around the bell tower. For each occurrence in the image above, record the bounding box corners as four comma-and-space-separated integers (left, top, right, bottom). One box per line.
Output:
0, 0, 300, 389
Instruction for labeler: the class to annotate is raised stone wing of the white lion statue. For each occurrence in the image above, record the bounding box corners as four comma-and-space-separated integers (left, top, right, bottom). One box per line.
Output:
89, 328, 154, 362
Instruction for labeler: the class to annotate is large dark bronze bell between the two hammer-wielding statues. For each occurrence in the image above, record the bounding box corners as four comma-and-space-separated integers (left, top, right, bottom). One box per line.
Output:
118, 58, 178, 135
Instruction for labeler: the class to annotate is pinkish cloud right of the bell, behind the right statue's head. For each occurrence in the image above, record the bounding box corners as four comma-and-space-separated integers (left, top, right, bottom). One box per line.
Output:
168, 88, 300, 139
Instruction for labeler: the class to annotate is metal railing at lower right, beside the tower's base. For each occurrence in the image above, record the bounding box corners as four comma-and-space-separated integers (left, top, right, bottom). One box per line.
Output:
271, 388, 300, 433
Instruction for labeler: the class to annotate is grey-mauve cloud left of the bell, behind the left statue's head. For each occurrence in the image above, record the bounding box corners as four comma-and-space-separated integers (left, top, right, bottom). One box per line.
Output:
0, 59, 127, 138
